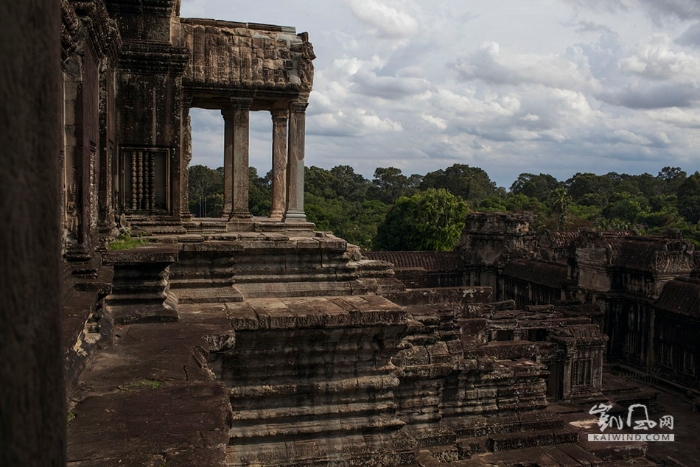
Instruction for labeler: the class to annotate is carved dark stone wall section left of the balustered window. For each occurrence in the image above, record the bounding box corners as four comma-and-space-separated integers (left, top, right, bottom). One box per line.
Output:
60, 0, 120, 260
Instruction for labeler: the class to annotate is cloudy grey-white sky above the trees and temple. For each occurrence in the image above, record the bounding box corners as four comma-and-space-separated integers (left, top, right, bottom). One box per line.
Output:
181, 0, 700, 187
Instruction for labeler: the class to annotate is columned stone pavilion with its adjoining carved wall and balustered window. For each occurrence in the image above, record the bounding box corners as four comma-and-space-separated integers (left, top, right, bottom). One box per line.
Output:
62, 0, 315, 259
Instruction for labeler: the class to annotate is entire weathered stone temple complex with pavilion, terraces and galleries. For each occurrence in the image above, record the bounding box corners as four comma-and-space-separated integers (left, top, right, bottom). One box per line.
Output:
0, 0, 700, 467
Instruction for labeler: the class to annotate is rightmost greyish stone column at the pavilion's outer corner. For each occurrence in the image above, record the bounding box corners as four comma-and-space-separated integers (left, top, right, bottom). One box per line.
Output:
284, 102, 309, 222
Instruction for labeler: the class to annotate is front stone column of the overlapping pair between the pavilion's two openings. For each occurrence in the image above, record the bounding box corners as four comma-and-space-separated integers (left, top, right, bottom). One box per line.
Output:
229, 99, 253, 222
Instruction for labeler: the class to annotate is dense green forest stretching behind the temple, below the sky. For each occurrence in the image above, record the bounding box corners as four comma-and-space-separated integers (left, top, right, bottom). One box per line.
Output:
189, 164, 700, 250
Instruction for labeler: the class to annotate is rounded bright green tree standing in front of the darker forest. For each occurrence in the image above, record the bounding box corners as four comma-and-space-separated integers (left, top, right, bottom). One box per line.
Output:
375, 188, 469, 251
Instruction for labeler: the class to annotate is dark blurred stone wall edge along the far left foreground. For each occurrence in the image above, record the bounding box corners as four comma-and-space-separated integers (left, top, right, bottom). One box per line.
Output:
0, 0, 66, 467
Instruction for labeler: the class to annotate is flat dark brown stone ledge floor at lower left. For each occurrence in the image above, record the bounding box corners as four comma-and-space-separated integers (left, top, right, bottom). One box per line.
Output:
68, 305, 231, 467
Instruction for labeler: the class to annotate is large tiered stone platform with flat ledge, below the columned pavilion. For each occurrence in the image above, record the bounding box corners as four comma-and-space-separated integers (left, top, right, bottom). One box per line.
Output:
68, 239, 656, 467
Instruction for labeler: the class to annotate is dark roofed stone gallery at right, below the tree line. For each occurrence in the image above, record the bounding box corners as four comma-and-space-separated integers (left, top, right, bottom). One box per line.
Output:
459, 213, 700, 390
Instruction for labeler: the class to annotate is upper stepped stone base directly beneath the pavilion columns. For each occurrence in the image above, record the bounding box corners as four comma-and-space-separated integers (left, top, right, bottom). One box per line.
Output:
158, 232, 404, 304
